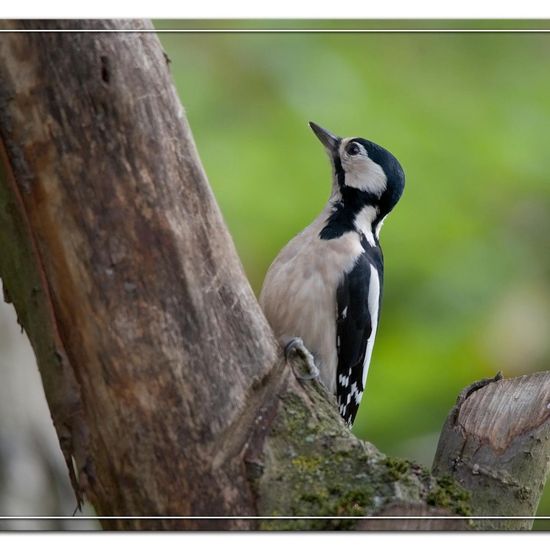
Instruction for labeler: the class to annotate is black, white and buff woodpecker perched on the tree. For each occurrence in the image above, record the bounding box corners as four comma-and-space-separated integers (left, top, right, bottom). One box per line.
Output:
259, 122, 405, 427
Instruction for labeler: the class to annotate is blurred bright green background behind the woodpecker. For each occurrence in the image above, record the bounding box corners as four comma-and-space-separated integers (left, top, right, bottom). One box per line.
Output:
157, 22, 550, 515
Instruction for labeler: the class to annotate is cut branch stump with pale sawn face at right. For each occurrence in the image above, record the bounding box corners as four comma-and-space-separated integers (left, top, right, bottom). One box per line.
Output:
433, 372, 550, 529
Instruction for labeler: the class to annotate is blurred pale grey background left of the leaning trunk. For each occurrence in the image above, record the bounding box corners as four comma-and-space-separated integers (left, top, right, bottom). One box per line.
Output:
0, 296, 99, 531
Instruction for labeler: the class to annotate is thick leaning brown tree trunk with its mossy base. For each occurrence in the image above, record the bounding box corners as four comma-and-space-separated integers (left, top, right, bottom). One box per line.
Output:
0, 21, 542, 529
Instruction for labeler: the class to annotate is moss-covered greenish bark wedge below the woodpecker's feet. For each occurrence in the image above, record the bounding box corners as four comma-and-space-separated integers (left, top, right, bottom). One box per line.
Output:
245, 374, 469, 530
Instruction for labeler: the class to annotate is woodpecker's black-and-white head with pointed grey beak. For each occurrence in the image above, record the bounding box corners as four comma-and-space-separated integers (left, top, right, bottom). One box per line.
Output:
309, 122, 405, 219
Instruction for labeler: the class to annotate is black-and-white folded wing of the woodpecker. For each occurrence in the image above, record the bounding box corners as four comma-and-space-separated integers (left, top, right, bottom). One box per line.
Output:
336, 254, 381, 425
